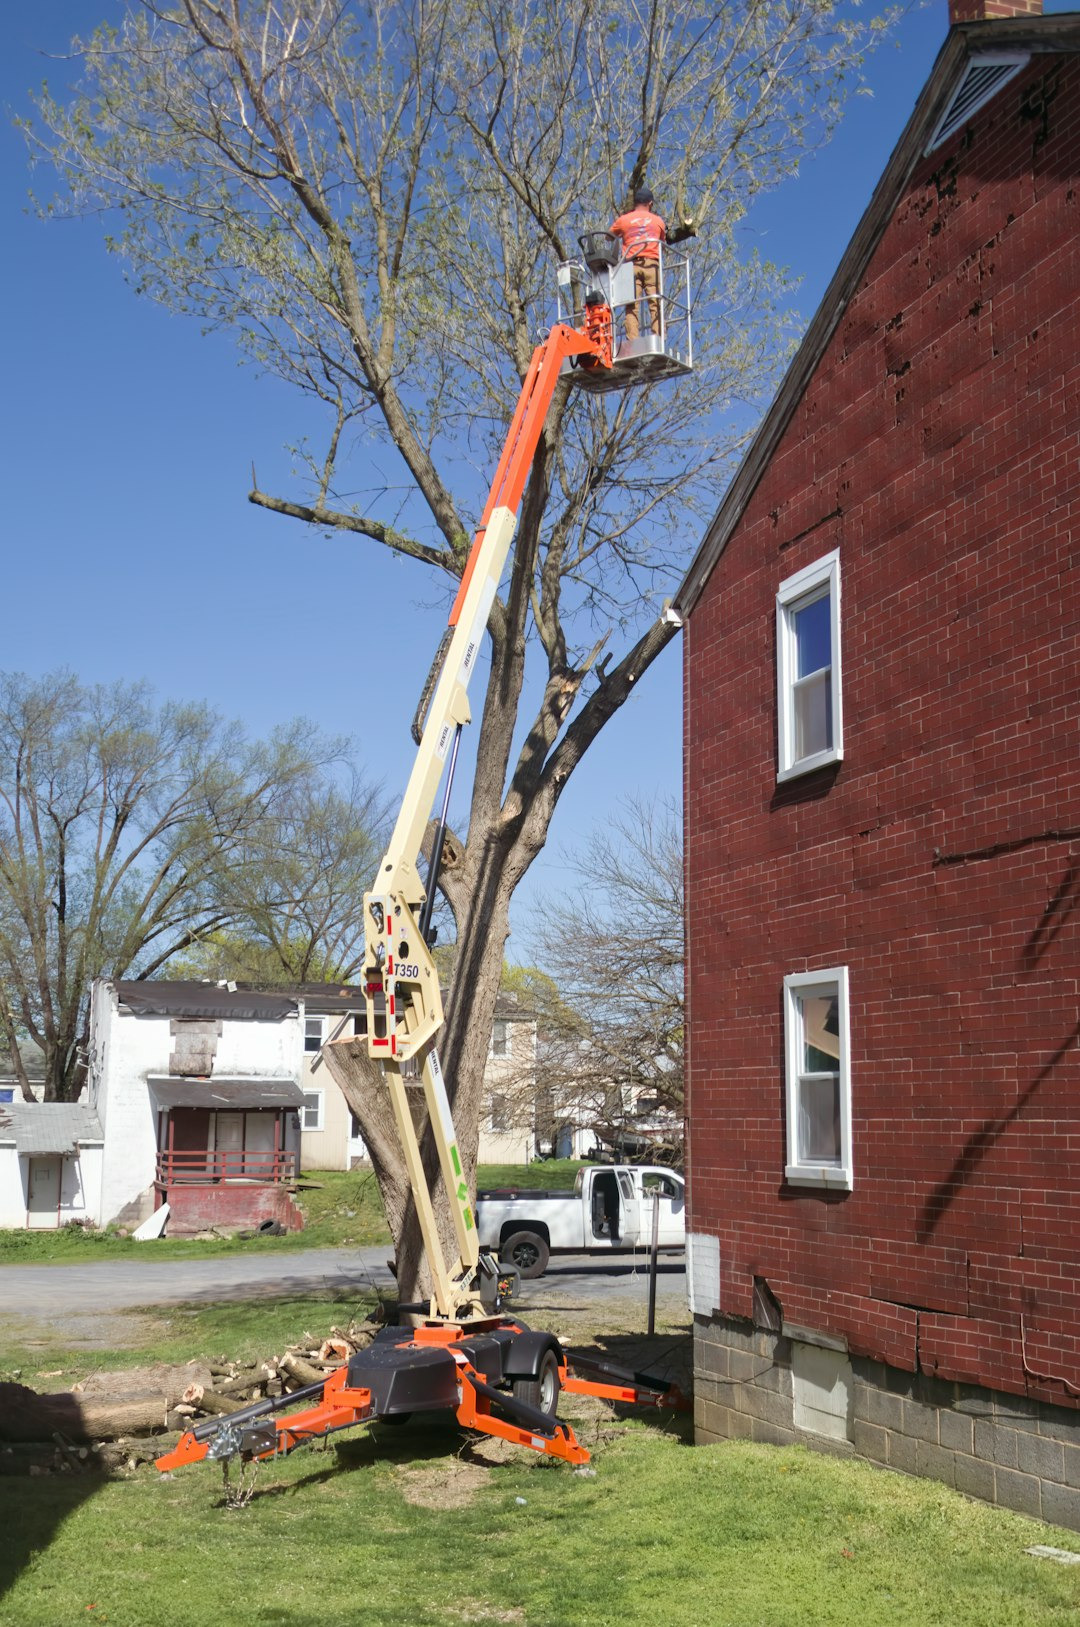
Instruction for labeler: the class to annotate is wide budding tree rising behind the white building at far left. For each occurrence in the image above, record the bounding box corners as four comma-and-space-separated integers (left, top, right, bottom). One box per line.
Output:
0, 674, 370, 1101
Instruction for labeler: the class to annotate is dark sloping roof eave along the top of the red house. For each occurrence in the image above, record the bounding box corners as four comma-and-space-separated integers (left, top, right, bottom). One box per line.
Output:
672, 11, 1080, 622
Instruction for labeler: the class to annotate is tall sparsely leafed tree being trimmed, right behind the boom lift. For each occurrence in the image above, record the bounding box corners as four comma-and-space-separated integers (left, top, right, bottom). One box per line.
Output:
28, 0, 882, 1277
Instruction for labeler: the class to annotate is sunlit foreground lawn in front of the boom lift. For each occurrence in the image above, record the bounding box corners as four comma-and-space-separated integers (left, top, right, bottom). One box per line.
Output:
0, 1419, 1080, 1627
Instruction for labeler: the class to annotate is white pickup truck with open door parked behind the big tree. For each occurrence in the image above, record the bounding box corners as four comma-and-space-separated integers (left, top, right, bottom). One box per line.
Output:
477, 1163, 686, 1277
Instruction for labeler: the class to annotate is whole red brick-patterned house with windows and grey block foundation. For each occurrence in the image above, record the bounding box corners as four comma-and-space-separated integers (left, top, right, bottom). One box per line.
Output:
673, 0, 1080, 1528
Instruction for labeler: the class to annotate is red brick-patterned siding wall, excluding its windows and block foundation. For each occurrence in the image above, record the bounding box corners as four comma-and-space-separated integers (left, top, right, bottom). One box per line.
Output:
686, 59, 1080, 1401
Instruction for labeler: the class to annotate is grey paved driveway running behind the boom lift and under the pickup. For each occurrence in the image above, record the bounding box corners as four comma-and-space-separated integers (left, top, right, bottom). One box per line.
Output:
0, 1243, 686, 1316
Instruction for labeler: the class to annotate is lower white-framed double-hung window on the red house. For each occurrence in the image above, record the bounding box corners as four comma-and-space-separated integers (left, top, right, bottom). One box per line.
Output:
784, 966, 852, 1191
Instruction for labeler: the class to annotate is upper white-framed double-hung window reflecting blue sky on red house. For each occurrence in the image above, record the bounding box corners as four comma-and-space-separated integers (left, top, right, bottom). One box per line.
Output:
776, 552, 844, 779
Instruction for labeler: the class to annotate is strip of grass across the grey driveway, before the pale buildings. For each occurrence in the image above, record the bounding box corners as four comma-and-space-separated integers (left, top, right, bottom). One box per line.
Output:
0, 1158, 581, 1266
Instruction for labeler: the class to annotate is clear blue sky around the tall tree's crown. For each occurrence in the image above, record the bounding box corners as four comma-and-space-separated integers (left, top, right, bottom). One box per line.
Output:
0, 0, 1069, 958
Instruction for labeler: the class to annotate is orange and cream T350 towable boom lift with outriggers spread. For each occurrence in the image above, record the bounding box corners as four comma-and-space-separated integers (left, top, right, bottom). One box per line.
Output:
158, 233, 691, 1490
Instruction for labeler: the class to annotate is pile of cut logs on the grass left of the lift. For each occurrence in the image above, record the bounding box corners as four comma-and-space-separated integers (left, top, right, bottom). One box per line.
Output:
0, 1323, 377, 1476
